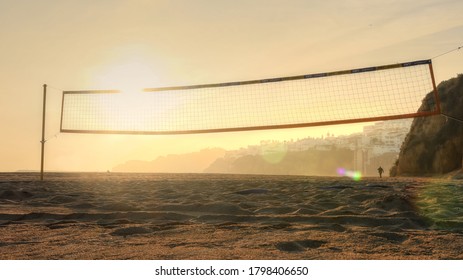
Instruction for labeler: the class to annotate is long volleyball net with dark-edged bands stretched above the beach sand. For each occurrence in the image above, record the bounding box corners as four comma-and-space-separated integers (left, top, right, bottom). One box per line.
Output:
61, 60, 438, 134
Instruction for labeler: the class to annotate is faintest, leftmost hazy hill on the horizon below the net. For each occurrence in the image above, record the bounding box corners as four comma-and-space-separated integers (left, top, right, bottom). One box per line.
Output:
112, 148, 225, 173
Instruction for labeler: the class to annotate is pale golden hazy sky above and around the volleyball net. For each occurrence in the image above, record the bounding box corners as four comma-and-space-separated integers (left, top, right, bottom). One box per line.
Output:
0, 0, 463, 172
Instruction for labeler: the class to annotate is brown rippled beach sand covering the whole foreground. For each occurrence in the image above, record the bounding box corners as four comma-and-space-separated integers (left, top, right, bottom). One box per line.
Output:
0, 173, 463, 260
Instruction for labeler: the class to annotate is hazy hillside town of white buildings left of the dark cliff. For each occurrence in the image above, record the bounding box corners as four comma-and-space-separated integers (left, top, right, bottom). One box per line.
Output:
224, 119, 412, 176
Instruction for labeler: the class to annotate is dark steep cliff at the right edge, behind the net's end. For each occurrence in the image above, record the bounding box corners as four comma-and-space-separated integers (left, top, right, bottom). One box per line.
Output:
391, 74, 463, 176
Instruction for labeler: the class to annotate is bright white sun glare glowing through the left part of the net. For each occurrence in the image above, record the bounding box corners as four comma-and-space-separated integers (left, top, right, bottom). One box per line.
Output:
82, 53, 169, 131
